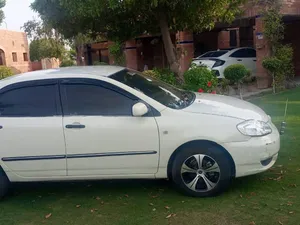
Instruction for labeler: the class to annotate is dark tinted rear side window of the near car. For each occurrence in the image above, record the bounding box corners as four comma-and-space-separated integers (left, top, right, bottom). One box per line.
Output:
0, 85, 58, 117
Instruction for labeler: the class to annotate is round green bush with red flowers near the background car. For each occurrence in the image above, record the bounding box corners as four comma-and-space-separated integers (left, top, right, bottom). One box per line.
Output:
184, 66, 218, 92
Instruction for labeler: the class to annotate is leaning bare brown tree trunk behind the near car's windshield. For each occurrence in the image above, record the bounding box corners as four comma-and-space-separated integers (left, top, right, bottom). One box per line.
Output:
158, 12, 183, 83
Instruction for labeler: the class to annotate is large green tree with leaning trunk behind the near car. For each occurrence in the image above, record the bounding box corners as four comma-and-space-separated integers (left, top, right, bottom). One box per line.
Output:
32, 0, 243, 80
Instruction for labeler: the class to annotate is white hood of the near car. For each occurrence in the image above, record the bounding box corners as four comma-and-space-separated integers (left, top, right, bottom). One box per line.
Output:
183, 93, 269, 122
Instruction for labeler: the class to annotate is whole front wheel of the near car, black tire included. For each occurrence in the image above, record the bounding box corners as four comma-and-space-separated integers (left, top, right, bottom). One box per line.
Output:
172, 146, 233, 197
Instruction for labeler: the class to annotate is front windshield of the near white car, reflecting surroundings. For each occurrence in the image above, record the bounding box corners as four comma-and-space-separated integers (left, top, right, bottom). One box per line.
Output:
110, 70, 196, 109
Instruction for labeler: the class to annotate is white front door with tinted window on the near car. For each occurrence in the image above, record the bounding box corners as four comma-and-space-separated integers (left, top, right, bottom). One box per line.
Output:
61, 79, 159, 176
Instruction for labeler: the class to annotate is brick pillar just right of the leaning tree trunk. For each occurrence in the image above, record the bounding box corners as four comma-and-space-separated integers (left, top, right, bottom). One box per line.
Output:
176, 31, 194, 72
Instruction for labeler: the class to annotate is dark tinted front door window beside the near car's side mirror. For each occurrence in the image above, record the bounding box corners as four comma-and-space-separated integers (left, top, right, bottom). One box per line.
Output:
63, 83, 135, 116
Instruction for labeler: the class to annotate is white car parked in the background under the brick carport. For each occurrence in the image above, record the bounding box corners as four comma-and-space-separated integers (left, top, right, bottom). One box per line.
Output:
192, 48, 256, 78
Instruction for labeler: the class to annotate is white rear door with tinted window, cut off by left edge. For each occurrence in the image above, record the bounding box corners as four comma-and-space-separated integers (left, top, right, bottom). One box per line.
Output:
0, 80, 66, 178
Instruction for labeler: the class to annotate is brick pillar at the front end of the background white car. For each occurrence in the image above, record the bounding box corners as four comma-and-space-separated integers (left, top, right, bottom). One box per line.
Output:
253, 16, 272, 89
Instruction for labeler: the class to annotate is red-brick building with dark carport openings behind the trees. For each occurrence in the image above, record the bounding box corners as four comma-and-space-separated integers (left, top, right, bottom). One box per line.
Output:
86, 0, 300, 88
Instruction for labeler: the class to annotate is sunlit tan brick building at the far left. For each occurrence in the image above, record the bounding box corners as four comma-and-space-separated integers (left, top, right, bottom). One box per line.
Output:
0, 30, 31, 73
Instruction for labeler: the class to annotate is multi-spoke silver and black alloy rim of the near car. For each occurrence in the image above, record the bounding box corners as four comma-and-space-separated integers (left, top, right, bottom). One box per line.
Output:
181, 154, 221, 192
